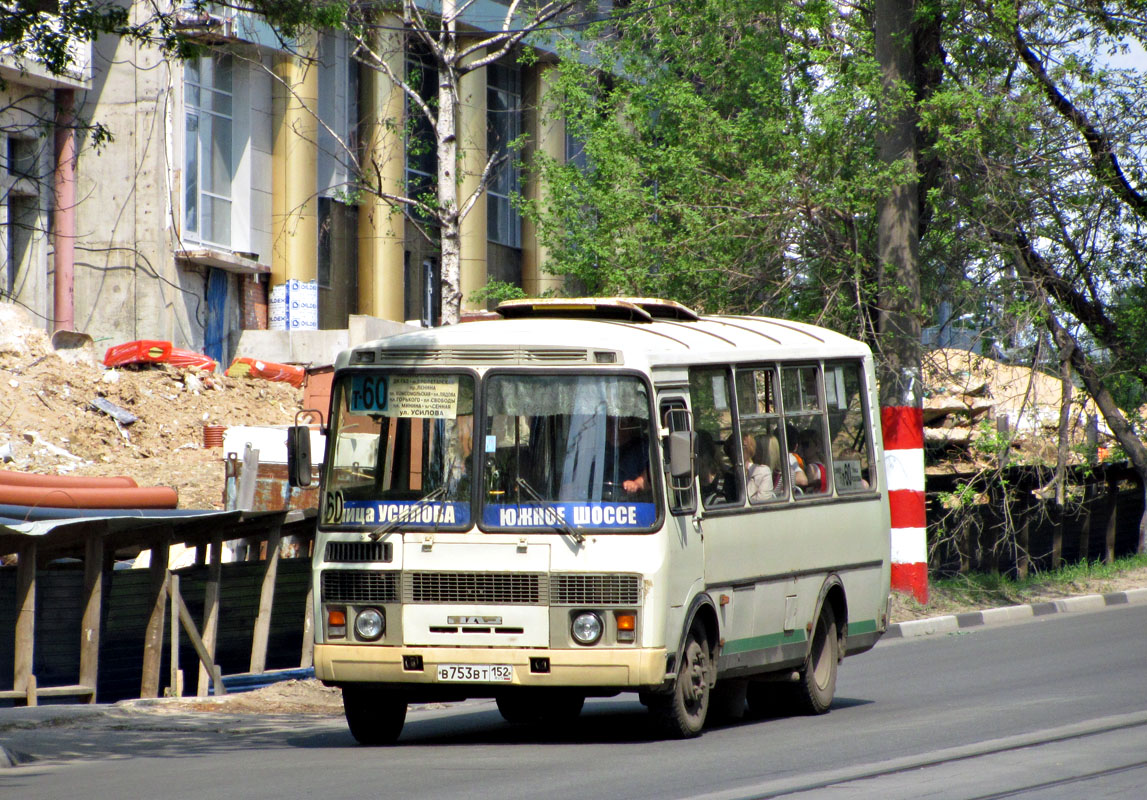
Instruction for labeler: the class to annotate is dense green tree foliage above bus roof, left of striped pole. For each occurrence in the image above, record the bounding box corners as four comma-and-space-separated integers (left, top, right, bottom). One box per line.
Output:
526, 0, 891, 333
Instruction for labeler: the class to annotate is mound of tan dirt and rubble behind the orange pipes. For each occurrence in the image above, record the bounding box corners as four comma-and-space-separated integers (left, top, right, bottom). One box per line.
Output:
0, 303, 302, 508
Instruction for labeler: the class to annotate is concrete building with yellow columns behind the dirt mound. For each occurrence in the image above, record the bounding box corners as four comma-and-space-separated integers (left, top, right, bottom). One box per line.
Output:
0, 0, 565, 363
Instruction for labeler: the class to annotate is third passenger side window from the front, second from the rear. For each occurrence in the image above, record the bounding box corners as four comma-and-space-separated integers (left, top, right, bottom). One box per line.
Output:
781, 366, 833, 497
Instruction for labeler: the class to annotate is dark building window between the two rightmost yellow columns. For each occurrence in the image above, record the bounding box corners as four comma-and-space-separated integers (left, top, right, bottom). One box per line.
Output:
486, 64, 522, 247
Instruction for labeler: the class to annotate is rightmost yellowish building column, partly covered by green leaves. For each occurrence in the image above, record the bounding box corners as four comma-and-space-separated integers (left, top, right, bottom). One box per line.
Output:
522, 63, 565, 297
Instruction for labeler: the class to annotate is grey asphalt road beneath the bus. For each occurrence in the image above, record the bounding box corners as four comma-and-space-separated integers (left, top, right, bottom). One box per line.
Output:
0, 605, 1147, 800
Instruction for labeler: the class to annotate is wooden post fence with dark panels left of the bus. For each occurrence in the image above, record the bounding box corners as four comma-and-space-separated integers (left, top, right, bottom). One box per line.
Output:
0, 511, 314, 705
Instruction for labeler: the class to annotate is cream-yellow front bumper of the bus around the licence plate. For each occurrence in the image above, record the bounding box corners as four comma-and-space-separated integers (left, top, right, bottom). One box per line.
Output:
314, 644, 666, 692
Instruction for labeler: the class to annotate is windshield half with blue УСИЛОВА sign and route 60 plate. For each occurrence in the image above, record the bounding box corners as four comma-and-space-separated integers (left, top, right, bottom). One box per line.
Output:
320, 371, 474, 529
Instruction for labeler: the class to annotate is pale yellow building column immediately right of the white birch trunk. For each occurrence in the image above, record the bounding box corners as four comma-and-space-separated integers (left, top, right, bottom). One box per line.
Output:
458, 51, 487, 311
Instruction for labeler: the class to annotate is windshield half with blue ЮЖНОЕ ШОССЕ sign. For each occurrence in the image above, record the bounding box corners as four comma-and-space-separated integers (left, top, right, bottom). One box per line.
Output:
481, 374, 658, 530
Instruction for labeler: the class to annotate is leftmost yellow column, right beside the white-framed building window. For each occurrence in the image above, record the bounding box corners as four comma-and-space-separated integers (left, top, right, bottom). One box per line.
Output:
271, 34, 319, 286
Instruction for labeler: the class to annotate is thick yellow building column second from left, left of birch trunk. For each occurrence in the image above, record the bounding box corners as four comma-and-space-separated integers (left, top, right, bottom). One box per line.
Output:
358, 16, 406, 321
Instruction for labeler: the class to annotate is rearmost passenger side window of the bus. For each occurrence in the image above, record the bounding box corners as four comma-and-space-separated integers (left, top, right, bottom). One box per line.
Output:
825, 363, 876, 495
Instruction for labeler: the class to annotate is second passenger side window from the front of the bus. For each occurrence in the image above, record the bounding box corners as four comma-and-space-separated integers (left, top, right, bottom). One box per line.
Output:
736, 367, 788, 505
